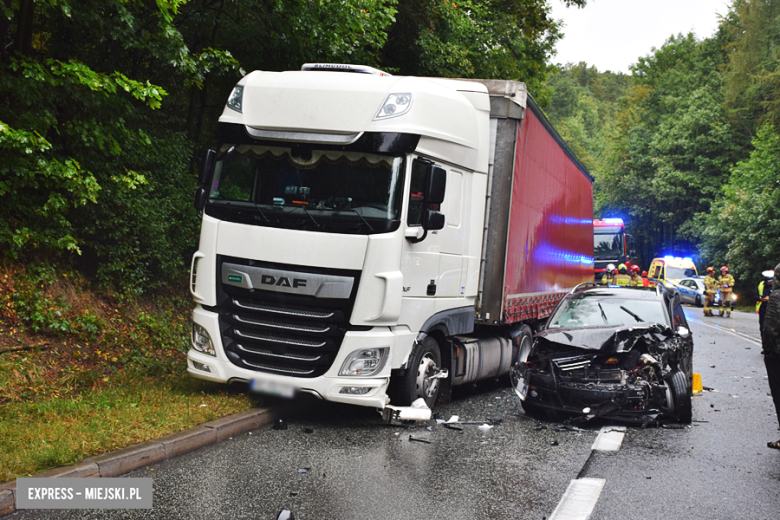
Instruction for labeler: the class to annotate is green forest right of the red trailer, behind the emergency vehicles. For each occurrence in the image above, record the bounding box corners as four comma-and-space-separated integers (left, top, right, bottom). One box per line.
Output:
546, 0, 780, 288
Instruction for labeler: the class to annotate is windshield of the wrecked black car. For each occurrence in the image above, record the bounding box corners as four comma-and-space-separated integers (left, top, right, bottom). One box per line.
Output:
547, 292, 667, 329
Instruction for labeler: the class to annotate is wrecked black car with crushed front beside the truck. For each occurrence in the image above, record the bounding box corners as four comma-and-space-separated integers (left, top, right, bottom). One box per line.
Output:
512, 283, 693, 425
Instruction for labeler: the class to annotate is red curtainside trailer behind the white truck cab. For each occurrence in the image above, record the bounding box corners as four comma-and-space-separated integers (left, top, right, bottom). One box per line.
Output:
477, 87, 593, 325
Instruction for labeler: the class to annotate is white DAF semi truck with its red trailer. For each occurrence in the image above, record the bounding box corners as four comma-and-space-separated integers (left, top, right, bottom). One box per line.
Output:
187, 64, 593, 415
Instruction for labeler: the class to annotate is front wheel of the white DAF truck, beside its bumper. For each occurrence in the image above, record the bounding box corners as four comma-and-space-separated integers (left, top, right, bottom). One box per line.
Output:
390, 336, 441, 408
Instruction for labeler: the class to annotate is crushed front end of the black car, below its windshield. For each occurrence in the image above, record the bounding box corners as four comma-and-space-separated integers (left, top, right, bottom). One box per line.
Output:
512, 286, 693, 424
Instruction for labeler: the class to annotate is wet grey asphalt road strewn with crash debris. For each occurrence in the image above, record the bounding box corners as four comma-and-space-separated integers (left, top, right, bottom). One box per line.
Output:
10, 307, 780, 520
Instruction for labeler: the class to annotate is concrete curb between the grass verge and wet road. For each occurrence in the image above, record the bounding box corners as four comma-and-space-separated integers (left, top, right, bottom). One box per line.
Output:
0, 408, 277, 516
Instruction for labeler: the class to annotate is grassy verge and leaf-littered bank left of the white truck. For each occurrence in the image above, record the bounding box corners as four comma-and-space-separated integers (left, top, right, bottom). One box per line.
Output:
0, 264, 258, 482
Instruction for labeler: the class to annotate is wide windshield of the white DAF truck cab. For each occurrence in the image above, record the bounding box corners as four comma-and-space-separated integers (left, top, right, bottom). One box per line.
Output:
206, 144, 404, 234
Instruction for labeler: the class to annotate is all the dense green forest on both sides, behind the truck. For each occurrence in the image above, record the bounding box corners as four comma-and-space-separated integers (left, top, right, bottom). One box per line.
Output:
0, 0, 780, 294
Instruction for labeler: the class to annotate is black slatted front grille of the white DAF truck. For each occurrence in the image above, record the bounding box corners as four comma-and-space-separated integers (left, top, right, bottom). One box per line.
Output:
213, 257, 359, 377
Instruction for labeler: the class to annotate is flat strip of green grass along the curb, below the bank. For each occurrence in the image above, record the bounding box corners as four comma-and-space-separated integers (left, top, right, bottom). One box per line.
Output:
0, 374, 255, 482
